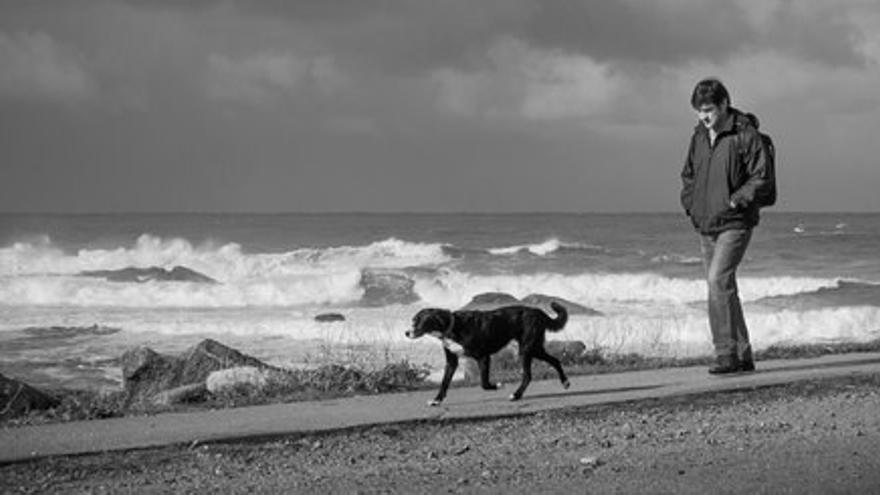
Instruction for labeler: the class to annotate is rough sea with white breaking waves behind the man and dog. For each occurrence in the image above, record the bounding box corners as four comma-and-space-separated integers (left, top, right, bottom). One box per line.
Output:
0, 211, 880, 389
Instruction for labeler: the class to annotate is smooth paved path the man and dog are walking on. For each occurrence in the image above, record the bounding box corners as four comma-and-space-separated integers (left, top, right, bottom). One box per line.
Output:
0, 353, 880, 464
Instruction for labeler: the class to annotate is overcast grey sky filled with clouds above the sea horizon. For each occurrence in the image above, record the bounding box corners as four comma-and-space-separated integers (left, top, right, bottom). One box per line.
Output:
0, 0, 880, 212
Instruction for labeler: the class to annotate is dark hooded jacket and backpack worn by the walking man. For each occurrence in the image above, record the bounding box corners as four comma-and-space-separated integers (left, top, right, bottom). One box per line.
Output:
681, 107, 772, 234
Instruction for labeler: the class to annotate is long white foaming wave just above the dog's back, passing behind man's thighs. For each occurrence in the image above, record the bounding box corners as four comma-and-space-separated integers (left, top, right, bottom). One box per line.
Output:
0, 266, 838, 307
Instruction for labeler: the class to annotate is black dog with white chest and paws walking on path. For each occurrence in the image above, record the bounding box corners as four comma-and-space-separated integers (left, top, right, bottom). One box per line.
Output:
406, 302, 569, 406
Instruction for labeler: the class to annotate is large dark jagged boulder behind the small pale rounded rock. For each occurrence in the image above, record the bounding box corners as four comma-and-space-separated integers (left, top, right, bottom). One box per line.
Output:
122, 339, 275, 404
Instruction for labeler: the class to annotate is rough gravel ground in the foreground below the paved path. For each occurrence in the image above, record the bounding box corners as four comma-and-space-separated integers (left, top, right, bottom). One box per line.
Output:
0, 375, 880, 494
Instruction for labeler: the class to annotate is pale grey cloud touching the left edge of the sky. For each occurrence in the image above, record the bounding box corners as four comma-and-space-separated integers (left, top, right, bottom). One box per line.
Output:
0, 31, 96, 101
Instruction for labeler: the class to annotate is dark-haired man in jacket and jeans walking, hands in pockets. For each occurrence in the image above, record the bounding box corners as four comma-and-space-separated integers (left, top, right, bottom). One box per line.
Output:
681, 79, 772, 375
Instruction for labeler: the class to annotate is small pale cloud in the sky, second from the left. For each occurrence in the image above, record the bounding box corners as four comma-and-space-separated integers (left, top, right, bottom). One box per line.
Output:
206, 53, 347, 104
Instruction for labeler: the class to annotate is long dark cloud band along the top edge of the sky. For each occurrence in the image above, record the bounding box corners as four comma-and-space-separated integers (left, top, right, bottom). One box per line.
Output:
120, 0, 864, 72
